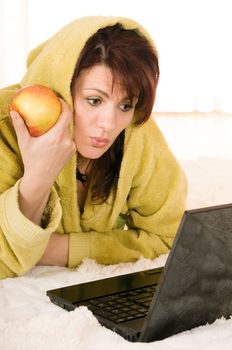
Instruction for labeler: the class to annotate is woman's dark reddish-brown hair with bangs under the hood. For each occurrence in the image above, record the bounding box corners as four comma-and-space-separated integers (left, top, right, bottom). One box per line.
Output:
71, 24, 159, 202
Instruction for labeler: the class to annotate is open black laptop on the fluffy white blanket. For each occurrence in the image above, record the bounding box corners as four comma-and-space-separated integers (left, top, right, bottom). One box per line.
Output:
47, 204, 232, 342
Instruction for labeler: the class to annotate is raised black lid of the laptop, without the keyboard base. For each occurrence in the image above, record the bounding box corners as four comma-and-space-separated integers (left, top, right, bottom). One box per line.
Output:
141, 204, 232, 341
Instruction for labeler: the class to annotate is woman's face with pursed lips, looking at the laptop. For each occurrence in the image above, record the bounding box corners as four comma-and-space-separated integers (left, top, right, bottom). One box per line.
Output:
74, 65, 137, 159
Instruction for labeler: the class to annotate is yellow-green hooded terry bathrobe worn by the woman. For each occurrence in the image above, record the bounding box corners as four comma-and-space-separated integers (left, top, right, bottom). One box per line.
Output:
0, 16, 186, 278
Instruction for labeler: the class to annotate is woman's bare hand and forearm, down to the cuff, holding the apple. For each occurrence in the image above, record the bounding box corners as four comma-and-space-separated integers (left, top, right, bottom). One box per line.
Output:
10, 100, 76, 225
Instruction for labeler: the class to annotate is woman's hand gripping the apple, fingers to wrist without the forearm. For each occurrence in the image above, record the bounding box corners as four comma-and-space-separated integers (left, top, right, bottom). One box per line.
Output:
11, 99, 76, 188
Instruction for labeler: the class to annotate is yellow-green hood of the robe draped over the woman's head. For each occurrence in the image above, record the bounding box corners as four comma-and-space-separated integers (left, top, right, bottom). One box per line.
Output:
21, 16, 158, 113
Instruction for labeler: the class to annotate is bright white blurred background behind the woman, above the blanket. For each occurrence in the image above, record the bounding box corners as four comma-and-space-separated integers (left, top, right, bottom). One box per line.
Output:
0, 0, 232, 164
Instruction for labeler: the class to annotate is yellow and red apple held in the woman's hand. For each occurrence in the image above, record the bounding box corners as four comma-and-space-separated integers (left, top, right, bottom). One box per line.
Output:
9, 85, 61, 137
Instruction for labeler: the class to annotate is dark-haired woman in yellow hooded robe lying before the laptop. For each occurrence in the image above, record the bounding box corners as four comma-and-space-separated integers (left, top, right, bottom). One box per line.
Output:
0, 17, 186, 278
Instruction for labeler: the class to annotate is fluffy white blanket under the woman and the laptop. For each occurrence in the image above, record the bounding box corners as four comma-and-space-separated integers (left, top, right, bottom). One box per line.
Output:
0, 158, 232, 350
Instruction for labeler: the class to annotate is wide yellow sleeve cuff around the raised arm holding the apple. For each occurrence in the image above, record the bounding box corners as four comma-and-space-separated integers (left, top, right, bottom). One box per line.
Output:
0, 181, 62, 278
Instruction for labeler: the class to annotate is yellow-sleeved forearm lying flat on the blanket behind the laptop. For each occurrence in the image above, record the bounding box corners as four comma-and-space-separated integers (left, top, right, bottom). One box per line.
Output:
69, 229, 174, 267
